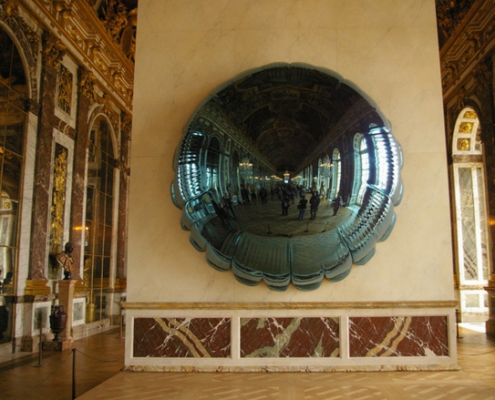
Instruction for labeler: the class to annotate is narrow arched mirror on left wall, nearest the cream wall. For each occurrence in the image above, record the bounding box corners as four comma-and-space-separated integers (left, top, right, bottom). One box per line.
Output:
83, 119, 115, 322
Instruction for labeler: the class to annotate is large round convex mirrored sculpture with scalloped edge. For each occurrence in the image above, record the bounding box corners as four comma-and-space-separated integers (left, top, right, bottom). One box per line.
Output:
172, 64, 402, 290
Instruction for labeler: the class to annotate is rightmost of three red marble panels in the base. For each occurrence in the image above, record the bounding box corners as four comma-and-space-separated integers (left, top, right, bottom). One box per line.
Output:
349, 316, 449, 357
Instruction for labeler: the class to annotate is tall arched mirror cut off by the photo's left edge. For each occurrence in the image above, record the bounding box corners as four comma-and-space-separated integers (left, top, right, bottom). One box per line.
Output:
0, 28, 29, 290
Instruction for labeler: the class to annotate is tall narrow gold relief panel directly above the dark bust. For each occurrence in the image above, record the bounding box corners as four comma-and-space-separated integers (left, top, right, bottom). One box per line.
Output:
50, 144, 67, 255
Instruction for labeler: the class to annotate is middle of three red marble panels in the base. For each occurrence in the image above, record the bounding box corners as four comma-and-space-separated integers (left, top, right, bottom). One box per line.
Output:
241, 318, 340, 358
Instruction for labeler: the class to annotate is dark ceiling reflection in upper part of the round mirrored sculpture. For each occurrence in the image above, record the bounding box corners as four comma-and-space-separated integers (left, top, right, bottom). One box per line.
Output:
216, 64, 382, 173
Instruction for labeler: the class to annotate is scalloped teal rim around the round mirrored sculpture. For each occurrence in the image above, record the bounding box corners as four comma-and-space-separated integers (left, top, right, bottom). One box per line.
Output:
171, 63, 404, 291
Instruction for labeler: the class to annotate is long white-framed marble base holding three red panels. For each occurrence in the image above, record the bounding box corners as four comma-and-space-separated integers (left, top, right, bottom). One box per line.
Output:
125, 308, 457, 372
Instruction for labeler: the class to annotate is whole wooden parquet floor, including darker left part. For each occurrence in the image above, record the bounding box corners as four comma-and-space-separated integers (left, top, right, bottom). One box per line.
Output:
0, 328, 495, 400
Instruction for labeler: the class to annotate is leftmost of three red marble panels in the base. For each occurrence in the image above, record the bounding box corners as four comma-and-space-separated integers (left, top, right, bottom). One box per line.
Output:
133, 318, 230, 358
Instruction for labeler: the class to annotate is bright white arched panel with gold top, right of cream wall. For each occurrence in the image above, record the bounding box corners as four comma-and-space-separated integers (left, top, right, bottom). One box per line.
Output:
452, 108, 489, 312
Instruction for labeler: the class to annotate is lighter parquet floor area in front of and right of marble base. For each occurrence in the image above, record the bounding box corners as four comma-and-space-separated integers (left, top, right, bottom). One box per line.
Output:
80, 324, 495, 400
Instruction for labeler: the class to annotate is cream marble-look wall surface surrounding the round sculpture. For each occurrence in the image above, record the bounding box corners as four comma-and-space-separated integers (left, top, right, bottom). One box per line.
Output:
128, 0, 453, 302
